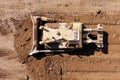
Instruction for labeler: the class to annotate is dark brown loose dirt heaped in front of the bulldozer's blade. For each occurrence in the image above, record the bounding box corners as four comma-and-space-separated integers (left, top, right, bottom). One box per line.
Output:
14, 17, 32, 61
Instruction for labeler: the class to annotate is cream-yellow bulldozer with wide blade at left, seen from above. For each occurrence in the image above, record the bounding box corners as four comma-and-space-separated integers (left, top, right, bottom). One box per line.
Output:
29, 15, 104, 56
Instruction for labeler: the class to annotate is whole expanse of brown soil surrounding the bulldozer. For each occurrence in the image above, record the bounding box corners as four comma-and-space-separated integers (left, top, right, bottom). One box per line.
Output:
0, 0, 120, 80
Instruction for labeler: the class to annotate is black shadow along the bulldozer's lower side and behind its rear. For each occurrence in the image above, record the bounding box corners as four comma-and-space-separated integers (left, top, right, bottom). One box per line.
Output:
33, 31, 109, 60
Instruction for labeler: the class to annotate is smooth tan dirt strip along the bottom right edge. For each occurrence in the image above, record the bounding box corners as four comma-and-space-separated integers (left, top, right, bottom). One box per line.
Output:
62, 72, 120, 80
